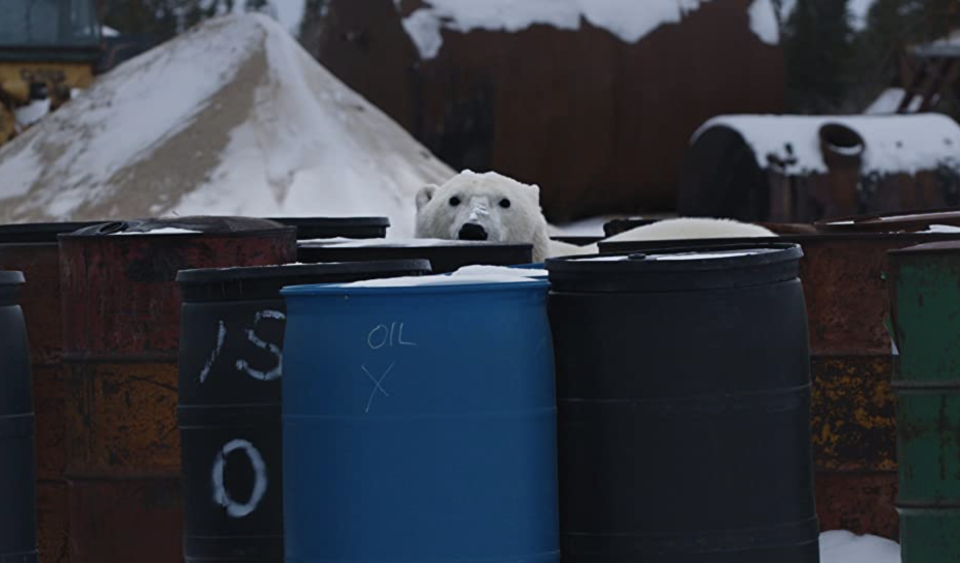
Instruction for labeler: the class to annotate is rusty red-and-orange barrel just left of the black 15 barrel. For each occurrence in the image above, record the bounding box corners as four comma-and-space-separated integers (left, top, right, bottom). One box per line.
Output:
60, 217, 296, 563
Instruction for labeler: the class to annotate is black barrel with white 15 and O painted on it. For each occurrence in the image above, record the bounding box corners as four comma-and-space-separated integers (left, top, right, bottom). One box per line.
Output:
177, 260, 429, 563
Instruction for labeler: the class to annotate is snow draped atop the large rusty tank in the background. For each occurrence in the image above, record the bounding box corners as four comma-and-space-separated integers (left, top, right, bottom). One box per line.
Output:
394, 0, 780, 60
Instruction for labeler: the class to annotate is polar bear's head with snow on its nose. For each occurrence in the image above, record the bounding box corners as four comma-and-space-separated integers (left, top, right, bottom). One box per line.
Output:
417, 170, 550, 262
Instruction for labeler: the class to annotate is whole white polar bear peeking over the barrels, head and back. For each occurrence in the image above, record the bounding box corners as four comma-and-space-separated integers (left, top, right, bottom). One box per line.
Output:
416, 170, 776, 262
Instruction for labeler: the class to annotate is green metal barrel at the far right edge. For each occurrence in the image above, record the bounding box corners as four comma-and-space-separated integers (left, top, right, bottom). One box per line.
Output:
888, 242, 960, 563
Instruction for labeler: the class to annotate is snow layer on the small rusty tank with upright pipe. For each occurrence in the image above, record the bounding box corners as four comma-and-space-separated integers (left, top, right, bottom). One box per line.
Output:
692, 113, 960, 174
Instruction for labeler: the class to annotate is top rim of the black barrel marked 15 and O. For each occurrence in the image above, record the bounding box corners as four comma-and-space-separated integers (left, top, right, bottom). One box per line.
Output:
176, 259, 430, 285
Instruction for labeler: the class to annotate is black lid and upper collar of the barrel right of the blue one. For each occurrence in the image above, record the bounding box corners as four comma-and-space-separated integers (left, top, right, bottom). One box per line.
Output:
546, 243, 803, 291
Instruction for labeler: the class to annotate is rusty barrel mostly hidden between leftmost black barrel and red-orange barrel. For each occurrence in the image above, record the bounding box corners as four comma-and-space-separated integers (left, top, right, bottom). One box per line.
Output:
0, 223, 97, 563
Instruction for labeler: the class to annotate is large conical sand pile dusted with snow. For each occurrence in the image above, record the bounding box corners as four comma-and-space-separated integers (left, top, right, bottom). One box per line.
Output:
0, 14, 454, 237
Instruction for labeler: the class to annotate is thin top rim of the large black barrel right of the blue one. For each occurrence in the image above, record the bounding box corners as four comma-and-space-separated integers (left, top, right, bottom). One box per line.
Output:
546, 242, 803, 274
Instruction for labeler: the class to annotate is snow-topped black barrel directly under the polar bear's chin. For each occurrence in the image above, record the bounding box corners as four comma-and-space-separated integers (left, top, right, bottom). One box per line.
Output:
297, 239, 533, 274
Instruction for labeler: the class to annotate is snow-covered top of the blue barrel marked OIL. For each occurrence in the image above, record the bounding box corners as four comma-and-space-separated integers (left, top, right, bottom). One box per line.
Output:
280, 270, 550, 297
